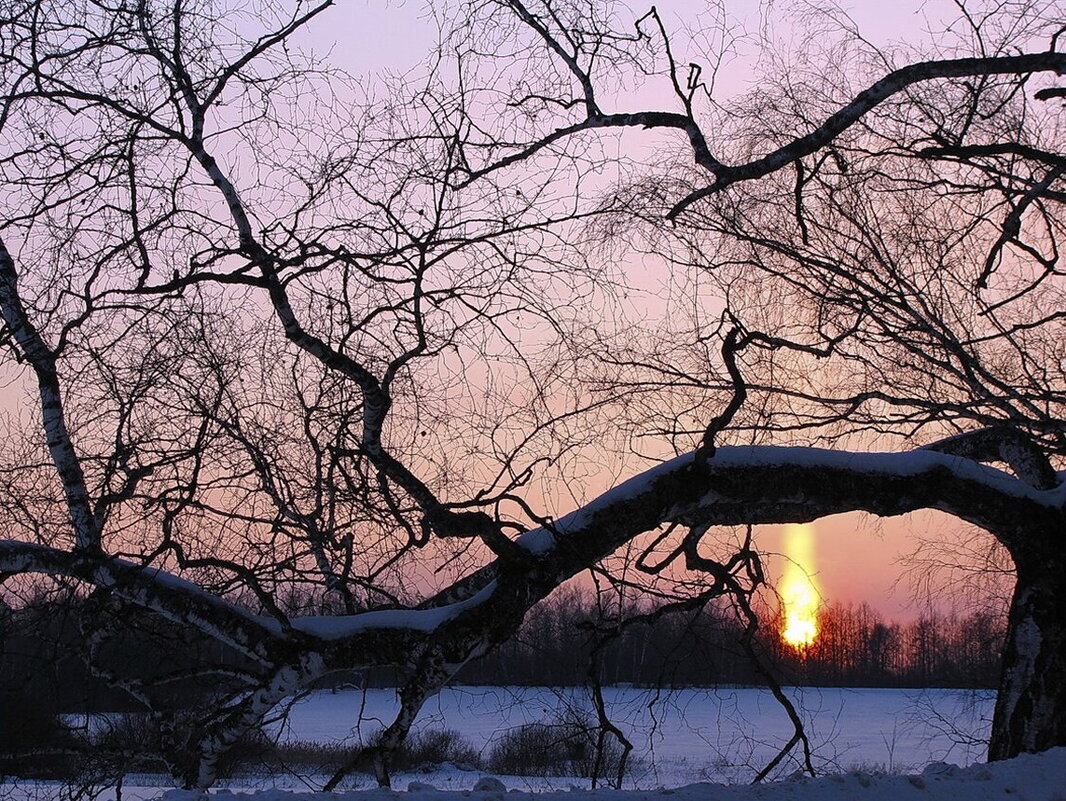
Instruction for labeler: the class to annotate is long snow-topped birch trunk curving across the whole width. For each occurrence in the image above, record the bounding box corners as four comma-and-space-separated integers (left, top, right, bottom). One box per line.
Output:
0, 446, 1066, 670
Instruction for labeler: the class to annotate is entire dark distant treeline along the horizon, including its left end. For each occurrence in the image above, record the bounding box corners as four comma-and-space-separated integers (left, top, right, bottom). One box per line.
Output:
0, 590, 1004, 711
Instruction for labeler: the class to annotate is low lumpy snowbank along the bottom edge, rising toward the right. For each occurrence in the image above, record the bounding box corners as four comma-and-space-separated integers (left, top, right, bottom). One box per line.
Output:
160, 748, 1066, 801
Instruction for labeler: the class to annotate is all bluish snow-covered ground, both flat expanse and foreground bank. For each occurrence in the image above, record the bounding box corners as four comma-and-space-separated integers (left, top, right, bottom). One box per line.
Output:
8, 687, 1048, 801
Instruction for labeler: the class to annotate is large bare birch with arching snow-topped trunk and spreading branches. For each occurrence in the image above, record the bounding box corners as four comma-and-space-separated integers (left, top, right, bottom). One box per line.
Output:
0, 0, 1066, 787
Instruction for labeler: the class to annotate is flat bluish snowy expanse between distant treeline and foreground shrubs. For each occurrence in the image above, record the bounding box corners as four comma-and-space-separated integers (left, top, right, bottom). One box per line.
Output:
262, 687, 995, 787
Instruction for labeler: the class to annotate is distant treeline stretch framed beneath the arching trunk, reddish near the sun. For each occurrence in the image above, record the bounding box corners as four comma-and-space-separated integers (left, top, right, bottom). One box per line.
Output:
458, 592, 1006, 688
